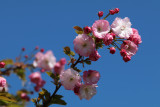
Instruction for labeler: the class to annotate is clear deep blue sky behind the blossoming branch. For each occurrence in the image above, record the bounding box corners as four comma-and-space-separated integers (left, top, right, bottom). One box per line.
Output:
0, 0, 160, 107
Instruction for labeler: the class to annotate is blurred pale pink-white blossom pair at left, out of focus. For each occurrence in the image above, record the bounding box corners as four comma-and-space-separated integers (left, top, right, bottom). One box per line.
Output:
33, 51, 56, 70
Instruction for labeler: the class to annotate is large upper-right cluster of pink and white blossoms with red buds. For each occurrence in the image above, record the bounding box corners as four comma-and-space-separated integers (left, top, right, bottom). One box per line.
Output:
73, 8, 142, 62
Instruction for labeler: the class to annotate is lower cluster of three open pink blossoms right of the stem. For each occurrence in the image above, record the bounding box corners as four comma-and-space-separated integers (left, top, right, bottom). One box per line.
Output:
60, 68, 100, 100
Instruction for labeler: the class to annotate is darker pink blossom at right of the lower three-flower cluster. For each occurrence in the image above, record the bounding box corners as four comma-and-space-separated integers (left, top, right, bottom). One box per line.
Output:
83, 70, 100, 85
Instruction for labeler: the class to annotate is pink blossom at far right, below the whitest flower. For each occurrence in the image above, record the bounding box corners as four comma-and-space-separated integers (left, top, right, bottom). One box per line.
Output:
121, 40, 138, 56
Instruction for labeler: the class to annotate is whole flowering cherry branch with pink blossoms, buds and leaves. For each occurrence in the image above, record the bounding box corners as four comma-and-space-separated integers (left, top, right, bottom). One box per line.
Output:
0, 8, 142, 107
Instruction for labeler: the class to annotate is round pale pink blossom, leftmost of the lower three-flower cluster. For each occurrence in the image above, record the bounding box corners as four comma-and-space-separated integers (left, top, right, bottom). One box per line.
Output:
60, 68, 81, 90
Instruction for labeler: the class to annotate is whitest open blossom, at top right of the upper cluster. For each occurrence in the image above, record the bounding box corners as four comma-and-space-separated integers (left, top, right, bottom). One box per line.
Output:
111, 17, 133, 39
